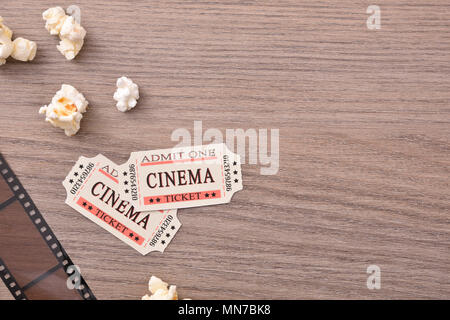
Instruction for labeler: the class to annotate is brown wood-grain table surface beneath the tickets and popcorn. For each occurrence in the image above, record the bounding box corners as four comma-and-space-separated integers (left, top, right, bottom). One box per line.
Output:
0, 0, 450, 299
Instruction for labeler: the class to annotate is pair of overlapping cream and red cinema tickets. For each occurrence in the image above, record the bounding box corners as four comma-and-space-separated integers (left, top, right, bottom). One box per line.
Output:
63, 144, 242, 255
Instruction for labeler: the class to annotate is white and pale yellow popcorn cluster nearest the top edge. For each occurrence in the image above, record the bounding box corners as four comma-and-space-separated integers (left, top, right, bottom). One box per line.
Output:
42, 7, 86, 60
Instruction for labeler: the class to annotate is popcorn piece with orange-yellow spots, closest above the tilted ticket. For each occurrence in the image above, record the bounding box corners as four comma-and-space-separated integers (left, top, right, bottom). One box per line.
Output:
39, 84, 88, 136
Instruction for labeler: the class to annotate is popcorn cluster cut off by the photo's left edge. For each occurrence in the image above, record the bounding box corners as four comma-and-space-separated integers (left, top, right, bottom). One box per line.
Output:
0, 16, 37, 65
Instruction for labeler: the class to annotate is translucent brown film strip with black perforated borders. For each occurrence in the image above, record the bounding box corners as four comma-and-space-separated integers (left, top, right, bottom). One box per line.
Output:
0, 153, 95, 300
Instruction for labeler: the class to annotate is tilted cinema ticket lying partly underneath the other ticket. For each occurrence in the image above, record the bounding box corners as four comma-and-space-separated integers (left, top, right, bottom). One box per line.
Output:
63, 155, 181, 255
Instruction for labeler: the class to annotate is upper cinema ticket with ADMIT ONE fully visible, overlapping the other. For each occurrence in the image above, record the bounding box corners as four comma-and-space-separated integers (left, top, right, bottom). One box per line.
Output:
119, 144, 242, 210
